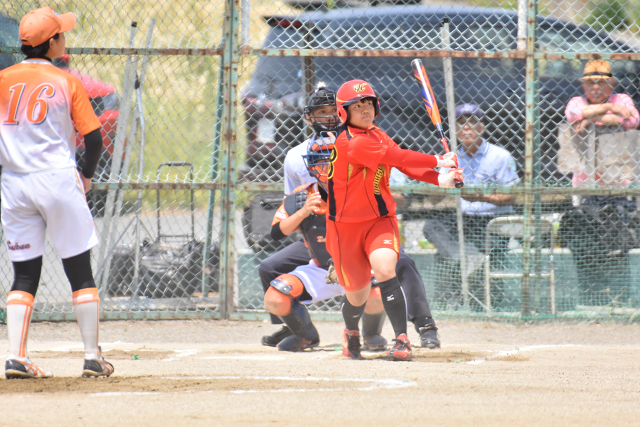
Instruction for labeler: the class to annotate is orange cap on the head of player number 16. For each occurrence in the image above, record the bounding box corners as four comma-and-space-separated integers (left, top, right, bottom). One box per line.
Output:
20, 7, 76, 46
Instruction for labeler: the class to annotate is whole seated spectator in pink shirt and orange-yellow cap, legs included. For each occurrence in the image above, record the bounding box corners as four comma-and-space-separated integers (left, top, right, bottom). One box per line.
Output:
559, 60, 640, 305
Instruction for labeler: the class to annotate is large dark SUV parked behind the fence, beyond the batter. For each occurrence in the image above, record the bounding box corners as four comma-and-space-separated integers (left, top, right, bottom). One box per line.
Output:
241, 6, 640, 182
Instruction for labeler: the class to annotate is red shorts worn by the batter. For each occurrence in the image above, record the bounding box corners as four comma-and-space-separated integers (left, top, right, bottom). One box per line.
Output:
327, 216, 400, 292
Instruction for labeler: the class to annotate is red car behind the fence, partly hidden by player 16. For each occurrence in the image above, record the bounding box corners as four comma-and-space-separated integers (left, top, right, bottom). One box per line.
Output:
0, 14, 120, 216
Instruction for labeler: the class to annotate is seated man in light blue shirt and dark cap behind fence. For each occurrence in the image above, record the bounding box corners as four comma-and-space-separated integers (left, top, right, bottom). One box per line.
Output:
424, 104, 520, 305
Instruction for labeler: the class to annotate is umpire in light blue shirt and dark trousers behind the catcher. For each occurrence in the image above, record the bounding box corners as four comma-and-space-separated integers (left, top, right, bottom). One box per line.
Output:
259, 88, 440, 349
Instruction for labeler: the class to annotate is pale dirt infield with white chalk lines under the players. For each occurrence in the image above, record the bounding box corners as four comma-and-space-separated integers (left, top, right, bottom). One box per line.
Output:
0, 321, 640, 427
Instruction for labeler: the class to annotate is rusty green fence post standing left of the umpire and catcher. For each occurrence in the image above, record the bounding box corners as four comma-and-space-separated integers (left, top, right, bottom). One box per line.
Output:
219, 0, 240, 319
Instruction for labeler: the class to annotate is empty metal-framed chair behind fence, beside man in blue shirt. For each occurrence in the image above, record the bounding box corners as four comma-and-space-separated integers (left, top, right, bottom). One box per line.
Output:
484, 216, 556, 314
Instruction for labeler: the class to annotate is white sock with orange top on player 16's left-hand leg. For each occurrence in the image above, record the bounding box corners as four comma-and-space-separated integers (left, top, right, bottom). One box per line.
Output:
7, 291, 33, 362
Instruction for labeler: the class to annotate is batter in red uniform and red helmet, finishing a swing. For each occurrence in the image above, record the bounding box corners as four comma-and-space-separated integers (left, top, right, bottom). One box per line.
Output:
327, 80, 462, 360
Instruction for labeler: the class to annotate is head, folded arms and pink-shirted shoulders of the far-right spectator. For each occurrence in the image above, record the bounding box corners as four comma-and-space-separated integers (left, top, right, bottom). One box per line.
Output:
565, 60, 640, 134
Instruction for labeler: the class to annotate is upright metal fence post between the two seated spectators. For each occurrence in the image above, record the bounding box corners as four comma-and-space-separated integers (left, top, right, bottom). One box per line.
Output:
520, 0, 538, 317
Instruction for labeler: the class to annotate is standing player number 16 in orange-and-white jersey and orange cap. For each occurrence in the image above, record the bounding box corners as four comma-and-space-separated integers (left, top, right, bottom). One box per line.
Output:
0, 7, 113, 378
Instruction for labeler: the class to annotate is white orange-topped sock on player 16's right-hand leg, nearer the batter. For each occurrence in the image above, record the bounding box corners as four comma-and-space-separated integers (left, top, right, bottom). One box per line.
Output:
73, 288, 100, 359
